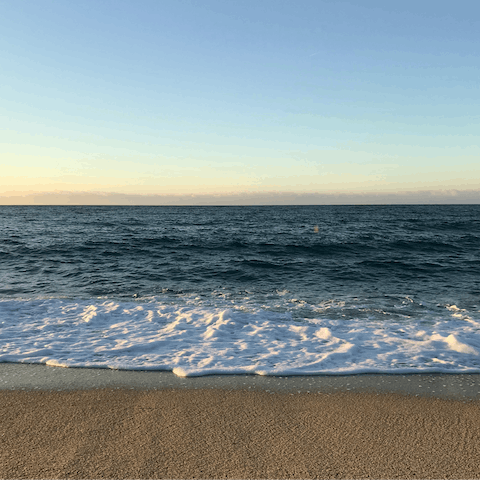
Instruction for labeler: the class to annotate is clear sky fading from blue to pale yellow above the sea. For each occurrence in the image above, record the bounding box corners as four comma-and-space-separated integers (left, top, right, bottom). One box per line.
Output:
0, 0, 480, 204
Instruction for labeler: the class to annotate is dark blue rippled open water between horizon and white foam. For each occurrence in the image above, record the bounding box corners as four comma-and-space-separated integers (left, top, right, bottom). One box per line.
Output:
0, 205, 480, 303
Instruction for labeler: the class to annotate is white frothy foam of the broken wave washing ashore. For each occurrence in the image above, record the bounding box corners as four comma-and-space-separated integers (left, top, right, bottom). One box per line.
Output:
0, 291, 480, 376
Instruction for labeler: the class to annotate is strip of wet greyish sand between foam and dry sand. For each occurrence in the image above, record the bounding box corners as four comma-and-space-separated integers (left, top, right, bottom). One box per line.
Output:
0, 363, 480, 401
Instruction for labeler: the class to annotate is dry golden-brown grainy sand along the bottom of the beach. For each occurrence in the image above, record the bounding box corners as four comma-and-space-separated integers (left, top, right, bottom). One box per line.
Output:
0, 389, 480, 480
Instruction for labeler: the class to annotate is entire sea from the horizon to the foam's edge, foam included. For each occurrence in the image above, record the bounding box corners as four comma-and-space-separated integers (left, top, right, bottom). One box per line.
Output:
0, 205, 480, 376
